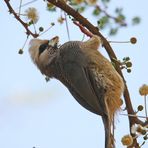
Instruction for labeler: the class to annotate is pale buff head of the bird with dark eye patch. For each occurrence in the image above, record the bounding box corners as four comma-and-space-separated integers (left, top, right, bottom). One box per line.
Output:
29, 36, 59, 71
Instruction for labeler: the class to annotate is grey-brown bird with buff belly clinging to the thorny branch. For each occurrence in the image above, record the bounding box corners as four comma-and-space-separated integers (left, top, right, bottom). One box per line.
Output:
29, 35, 124, 148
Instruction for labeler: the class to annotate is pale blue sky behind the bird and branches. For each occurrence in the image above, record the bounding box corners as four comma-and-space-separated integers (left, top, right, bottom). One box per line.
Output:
0, 0, 148, 148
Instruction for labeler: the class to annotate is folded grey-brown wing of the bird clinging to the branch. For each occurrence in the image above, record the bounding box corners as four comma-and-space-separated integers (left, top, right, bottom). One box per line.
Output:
56, 42, 105, 115
